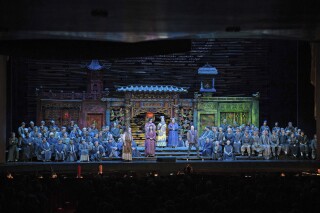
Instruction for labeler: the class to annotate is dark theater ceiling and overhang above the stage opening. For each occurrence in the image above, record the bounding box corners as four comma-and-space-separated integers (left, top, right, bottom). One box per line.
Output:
0, 0, 320, 56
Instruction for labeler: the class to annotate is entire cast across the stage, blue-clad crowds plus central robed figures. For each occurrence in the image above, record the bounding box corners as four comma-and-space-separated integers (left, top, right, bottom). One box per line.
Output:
8, 116, 317, 162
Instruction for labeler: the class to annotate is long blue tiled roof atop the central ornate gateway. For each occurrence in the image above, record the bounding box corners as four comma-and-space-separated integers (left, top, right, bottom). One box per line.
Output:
117, 85, 188, 93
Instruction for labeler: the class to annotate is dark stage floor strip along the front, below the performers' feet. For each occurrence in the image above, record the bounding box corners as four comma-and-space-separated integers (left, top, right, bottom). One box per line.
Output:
0, 158, 320, 176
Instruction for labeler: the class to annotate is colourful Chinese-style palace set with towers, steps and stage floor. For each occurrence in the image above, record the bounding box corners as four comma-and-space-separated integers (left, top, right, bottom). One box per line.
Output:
0, 57, 319, 176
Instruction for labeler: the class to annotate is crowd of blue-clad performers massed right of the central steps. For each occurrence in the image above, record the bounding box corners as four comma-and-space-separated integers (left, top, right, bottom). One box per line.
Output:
199, 121, 317, 160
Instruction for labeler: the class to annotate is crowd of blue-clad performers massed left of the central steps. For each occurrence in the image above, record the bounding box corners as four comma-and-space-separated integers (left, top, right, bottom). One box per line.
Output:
8, 121, 141, 162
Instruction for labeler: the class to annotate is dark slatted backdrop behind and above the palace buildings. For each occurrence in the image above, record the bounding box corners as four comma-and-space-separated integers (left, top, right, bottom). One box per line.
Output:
8, 39, 315, 136
